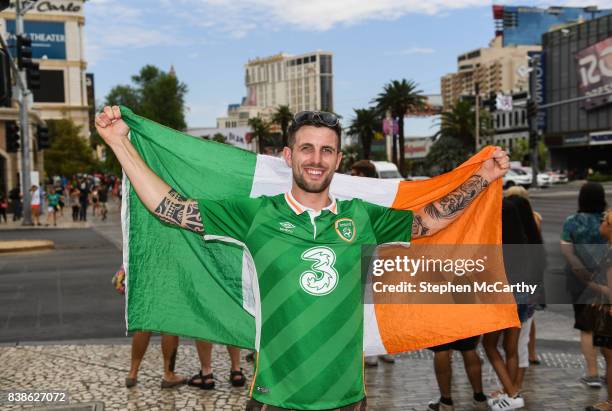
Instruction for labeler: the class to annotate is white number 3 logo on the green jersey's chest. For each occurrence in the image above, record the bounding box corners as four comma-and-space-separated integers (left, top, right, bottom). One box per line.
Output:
300, 247, 338, 296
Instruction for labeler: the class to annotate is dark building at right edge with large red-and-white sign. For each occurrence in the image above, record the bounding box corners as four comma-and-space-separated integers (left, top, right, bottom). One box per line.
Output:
534, 14, 612, 178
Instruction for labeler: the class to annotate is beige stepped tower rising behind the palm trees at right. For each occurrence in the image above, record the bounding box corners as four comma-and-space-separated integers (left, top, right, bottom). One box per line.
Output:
441, 36, 541, 110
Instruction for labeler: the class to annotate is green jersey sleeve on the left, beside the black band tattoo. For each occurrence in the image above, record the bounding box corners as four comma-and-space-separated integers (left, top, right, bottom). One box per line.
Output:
198, 197, 262, 242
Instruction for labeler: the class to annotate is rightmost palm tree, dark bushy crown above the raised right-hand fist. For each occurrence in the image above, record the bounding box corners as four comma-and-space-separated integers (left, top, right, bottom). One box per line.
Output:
438, 100, 492, 152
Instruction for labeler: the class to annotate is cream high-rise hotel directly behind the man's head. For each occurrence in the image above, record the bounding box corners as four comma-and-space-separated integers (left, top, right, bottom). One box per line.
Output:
217, 51, 334, 128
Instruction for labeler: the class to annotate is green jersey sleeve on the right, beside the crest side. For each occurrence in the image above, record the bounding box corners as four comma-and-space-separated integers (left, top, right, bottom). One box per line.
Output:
362, 202, 413, 244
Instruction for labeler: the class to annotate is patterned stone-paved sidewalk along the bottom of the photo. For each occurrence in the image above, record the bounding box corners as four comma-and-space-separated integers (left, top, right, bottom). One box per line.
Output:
0, 339, 605, 411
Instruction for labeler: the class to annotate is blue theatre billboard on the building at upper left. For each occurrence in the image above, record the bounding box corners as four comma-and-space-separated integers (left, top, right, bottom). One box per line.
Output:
6, 20, 66, 60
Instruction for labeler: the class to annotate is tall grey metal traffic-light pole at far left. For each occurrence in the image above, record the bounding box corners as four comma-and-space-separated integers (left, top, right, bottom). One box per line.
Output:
15, 0, 34, 225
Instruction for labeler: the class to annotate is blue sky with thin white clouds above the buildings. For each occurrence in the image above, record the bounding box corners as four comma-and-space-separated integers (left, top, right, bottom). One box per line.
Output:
84, 0, 612, 127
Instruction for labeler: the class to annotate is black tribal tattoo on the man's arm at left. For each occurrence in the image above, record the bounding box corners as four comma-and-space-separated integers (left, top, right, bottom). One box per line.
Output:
155, 189, 204, 233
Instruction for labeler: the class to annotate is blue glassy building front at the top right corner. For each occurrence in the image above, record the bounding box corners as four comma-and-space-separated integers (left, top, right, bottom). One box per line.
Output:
493, 5, 612, 47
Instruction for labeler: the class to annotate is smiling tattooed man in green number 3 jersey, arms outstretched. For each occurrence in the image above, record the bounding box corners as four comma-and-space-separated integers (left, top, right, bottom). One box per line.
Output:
96, 106, 509, 410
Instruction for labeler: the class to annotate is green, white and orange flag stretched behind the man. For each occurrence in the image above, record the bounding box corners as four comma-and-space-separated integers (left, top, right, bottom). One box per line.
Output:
121, 107, 519, 354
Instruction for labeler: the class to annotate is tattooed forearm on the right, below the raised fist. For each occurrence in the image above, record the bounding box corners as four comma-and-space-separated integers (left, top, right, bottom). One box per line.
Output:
412, 174, 489, 238
